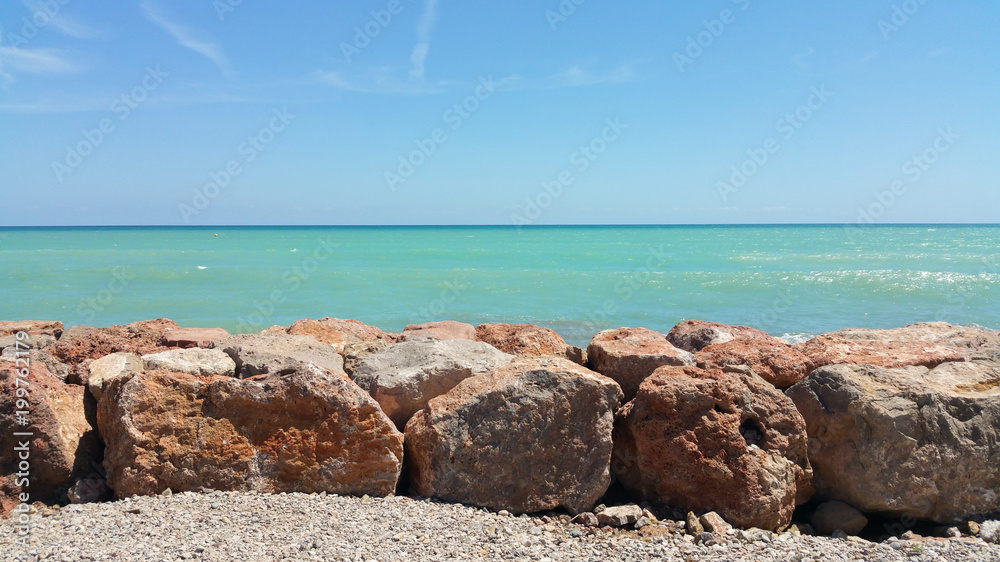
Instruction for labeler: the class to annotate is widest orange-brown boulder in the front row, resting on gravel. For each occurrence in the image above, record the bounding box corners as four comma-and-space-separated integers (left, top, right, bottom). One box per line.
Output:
97, 363, 403, 498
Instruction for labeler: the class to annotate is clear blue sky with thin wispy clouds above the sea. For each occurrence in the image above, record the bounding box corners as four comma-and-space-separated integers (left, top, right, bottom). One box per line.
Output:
0, 0, 1000, 226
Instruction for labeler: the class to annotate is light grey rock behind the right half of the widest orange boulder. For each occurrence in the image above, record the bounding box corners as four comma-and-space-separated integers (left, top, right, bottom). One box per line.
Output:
212, 334, 344, 379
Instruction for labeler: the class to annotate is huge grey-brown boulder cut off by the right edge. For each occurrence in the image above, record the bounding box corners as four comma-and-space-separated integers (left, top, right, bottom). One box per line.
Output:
786, 362, 1000, 524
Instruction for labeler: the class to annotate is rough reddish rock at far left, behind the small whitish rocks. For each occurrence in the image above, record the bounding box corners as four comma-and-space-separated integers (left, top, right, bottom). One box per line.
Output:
46, 318, 178, 367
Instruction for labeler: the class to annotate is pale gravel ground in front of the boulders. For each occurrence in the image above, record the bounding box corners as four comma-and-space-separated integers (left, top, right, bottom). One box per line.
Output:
0, 492, 1000, 562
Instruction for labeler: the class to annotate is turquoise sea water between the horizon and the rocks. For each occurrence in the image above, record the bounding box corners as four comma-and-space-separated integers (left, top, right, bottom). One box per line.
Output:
0, 225, 1000, 345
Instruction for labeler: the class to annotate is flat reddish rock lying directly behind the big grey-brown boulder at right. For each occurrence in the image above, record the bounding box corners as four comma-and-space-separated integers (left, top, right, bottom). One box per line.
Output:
793, 334, 967, 369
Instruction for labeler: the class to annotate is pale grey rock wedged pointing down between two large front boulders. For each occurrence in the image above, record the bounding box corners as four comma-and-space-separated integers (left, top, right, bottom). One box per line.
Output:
351, 340, 514, 429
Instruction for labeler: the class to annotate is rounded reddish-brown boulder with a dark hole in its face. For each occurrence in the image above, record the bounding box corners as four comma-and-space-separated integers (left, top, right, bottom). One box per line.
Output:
612, 367, 813, 531
